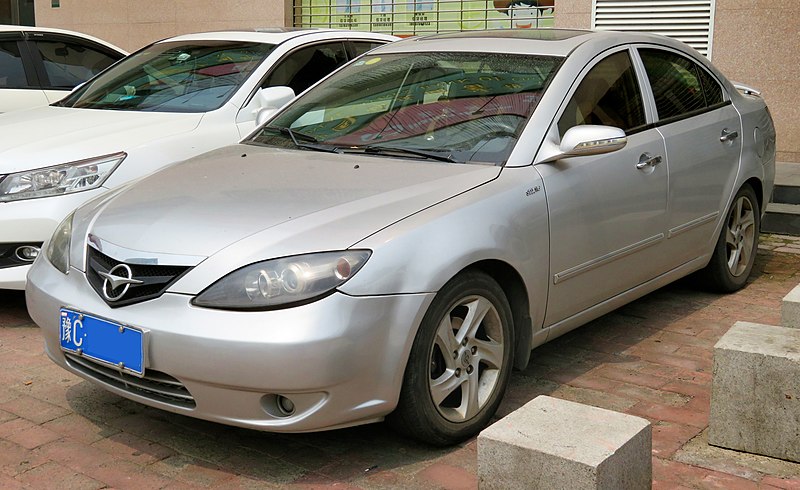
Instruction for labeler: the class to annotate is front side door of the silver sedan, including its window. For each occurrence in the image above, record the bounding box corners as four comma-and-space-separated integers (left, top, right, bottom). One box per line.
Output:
536, 49, 669, 326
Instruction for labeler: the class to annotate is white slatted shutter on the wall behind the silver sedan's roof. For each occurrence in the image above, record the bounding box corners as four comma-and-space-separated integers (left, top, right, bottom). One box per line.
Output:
592, 0, 716, 58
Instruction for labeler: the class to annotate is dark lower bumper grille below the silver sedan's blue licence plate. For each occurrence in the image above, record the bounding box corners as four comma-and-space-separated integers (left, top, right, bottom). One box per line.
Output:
64, 353, 196, 408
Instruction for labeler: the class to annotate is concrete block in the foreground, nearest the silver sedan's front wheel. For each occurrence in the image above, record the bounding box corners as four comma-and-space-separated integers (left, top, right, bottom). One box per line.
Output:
478, 395, 653, 490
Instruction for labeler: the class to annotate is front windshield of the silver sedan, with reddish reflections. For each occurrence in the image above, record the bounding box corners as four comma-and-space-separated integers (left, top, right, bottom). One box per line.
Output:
251, 53, 561, 164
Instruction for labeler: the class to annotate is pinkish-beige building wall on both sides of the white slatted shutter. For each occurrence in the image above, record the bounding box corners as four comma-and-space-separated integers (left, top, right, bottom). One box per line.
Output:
555, 0, 800, 162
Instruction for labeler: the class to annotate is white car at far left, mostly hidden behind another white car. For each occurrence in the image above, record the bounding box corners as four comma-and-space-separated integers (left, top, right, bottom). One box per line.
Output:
0, 25, 128, 112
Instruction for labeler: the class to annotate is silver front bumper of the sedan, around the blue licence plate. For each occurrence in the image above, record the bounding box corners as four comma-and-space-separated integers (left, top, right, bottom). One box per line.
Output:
26, 258, 433, 432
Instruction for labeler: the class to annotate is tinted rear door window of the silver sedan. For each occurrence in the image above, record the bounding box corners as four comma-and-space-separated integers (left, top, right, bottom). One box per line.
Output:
639, 49, 723, 120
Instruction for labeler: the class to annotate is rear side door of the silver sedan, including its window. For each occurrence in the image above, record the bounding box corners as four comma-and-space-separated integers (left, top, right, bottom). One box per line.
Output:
637, 48, 742, 267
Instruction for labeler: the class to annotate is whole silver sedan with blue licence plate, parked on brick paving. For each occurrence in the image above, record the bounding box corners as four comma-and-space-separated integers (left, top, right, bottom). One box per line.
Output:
27, 30, 775, 444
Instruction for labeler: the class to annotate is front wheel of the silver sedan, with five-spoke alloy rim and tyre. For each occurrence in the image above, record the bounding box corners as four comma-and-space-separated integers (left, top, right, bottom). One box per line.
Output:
388, 272, 514, 446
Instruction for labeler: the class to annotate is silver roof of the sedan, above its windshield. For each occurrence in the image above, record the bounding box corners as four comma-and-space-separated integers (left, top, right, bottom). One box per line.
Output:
372, 28, 681, 57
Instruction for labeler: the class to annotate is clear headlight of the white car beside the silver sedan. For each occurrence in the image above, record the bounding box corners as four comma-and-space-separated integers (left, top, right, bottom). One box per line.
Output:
0, 152, 127, 202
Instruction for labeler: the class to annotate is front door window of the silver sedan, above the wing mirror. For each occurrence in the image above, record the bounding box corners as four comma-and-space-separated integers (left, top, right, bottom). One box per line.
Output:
558, 51, 646, 136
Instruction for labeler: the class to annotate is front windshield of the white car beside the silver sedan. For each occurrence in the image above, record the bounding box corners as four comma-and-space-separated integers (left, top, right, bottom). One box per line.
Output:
59, 41, 275, 112
